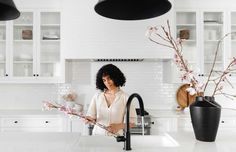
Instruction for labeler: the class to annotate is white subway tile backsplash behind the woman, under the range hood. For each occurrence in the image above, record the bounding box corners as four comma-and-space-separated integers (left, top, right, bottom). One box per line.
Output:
65, 61, 175, 109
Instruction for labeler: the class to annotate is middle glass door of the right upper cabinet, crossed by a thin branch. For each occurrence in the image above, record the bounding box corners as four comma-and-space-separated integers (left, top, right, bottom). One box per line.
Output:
203, 12, 224, 77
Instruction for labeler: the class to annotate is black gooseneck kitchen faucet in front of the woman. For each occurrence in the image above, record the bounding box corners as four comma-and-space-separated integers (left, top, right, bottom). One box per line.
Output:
116, 93, 144, 150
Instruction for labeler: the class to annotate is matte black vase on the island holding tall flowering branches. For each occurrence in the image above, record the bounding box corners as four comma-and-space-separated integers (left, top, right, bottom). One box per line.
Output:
190, 96, 221, 142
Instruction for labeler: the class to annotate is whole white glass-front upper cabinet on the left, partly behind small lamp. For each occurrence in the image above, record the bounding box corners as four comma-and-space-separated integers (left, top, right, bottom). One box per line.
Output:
0, 9, 64, 83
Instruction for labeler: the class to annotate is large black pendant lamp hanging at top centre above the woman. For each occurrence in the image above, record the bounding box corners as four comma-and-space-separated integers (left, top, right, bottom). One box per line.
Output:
94, 0, 171, 20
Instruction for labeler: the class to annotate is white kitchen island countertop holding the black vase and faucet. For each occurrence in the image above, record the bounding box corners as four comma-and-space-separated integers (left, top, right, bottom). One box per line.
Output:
0, 131, 236, 152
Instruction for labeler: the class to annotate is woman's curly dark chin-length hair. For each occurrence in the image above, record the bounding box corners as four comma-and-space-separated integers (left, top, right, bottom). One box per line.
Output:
96, 64, 126, 91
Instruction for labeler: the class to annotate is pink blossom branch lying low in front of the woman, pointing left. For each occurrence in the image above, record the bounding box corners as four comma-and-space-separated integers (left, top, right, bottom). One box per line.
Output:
43, 101, 118, 137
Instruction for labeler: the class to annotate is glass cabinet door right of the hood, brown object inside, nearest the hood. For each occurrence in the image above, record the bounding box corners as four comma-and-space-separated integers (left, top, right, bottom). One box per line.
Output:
176, 11, 199, 70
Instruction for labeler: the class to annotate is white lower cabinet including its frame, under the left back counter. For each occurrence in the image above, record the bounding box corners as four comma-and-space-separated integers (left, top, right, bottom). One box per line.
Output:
0, 116, 68, 132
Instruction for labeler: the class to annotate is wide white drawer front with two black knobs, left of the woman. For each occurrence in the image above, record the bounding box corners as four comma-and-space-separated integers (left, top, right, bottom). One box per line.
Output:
1, 118, 62, 127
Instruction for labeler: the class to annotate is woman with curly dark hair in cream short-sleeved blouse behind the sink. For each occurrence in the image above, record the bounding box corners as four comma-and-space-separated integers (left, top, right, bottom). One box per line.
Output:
87, 64, 136, 135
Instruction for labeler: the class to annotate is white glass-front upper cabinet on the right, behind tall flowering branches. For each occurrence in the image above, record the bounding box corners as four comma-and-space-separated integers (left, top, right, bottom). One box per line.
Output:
164, 9, 236, 83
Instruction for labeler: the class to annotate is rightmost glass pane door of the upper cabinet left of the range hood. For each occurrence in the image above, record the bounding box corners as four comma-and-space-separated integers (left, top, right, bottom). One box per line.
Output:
38, 12, 61, 77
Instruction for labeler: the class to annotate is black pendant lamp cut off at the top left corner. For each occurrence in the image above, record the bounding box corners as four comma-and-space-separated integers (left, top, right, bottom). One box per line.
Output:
0, 0, 20, 21
